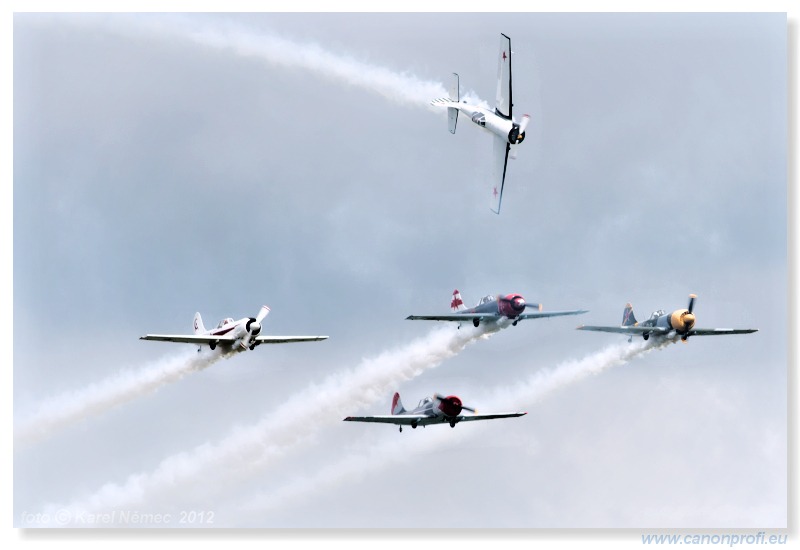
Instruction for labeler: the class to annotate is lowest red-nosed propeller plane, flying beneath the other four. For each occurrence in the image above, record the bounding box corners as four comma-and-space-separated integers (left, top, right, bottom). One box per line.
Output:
344, 393, 528, 432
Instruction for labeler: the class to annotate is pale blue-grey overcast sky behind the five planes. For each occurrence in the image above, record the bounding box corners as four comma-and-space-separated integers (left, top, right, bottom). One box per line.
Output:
13, 9, 788, 540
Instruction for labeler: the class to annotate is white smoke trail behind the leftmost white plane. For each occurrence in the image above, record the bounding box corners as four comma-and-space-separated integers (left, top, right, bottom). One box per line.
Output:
14, 350, 223, 444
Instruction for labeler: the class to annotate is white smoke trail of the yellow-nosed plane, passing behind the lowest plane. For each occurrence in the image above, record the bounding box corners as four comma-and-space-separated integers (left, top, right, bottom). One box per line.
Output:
242, 339, 675, 513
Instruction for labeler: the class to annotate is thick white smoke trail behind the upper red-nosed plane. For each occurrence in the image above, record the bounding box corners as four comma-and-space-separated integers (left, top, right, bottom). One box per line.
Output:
42, 325, 499, 524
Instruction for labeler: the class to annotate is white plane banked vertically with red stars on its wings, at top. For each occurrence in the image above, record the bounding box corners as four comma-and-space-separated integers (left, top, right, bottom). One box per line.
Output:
431, 34, 531, 214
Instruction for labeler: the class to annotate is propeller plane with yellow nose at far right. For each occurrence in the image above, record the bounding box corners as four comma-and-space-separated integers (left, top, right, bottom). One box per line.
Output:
578, 294, 758, 342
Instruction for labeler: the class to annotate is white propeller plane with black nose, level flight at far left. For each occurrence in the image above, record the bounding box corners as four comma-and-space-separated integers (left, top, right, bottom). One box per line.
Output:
139, 306, 328, 353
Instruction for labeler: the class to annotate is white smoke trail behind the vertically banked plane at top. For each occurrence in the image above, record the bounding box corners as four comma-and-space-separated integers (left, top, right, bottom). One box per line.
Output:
62, 14, 488, 111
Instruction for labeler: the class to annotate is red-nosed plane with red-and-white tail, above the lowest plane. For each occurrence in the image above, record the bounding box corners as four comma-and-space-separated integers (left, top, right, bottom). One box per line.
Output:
406, 289, 588, 327
